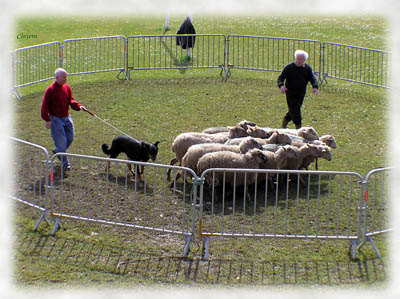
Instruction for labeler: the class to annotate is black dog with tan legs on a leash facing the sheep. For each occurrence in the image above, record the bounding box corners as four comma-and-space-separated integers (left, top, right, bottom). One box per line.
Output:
101, 136, 160, 182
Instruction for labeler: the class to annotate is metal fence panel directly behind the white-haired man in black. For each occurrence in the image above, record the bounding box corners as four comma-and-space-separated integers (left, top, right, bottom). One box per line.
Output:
226, 35, 323, 81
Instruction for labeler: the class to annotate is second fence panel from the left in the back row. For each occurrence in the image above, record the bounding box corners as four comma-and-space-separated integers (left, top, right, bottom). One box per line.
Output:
62, 36, 126, 75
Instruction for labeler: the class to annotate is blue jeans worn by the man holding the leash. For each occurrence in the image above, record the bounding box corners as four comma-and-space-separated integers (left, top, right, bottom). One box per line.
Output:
50, 115, 74, 168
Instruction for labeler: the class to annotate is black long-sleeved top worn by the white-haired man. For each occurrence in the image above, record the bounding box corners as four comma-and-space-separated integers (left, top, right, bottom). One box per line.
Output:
278, 62, 318, 93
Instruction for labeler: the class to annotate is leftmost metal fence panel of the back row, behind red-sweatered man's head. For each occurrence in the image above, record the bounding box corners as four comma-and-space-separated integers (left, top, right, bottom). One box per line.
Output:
12, 42, 61, 88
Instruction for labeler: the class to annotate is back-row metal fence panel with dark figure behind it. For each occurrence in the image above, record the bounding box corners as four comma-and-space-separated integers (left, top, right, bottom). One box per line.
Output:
127, 34, 225, 77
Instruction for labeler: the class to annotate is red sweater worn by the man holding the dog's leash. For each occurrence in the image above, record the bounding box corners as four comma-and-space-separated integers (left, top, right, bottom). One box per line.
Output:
41, 81, 81, 121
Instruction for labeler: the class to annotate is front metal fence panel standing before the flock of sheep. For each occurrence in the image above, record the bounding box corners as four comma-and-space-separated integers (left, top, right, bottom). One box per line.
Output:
200, 169, 362, 240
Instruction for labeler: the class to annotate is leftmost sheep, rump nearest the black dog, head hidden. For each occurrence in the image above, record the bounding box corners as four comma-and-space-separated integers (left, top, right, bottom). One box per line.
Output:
167, 132, 228, 180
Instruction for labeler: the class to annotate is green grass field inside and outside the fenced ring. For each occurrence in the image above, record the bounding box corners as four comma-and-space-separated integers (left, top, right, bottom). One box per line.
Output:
12, 16, 390, 287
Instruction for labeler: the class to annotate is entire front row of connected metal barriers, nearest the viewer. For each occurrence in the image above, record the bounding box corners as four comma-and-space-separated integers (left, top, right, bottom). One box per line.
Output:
10, 138, 391, 258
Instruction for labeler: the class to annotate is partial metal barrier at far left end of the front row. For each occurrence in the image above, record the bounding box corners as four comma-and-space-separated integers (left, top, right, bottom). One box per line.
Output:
9, 137, 51, 231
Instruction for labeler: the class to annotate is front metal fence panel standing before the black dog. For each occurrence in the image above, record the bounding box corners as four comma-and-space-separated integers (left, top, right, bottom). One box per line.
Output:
51, 153, 198, 236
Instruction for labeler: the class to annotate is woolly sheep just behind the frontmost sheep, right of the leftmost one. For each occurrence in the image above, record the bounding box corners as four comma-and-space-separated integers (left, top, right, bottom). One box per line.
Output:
182, 137, 262, 175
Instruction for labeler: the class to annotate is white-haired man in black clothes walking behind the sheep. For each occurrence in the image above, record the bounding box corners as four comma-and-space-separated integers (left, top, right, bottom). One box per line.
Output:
278, 50, 318, 129
